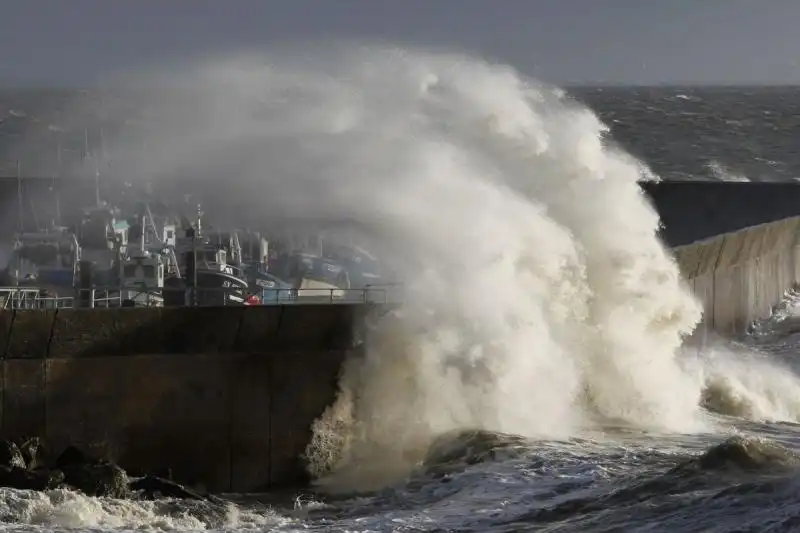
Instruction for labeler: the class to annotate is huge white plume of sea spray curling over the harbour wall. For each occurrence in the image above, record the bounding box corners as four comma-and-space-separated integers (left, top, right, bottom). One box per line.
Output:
53, 46, 700, 488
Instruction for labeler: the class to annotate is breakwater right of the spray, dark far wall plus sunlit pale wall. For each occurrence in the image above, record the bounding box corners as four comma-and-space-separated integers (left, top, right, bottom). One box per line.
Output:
642, 181, 800, 336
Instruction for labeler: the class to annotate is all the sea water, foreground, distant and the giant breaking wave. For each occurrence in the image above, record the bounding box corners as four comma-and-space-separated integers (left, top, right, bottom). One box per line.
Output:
0, 46, 800, 532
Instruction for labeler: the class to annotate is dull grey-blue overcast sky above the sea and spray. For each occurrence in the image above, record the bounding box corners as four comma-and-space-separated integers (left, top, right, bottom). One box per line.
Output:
0, 0, 800, 85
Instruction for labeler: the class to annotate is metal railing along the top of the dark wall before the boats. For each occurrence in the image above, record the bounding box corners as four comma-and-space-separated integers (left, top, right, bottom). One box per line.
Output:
0, 286, 401, 309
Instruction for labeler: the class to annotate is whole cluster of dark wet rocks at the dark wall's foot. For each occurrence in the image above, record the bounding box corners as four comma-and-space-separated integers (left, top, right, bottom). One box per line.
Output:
0, 437, 213, 500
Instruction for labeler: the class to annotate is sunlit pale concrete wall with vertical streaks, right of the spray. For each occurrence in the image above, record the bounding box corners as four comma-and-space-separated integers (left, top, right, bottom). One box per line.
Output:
673, 217, 800, 336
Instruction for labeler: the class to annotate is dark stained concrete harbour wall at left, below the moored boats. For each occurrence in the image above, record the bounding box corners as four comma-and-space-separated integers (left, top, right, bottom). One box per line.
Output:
0, 305, 368, 491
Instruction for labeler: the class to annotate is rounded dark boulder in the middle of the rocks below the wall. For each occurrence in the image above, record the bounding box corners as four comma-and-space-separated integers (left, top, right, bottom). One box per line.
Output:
56, 446, 129, 498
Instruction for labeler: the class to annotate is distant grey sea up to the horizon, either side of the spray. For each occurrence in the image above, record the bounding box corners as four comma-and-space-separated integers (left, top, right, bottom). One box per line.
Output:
0, 86, 800, 181
